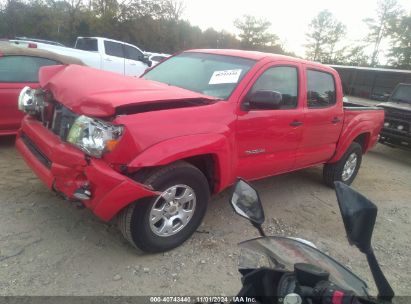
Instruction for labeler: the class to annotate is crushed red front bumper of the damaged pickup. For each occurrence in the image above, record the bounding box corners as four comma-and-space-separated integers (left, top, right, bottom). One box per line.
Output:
16, 116, 157, 221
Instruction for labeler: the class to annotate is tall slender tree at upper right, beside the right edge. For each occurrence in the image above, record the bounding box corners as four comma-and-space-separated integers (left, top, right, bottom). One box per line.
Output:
364, 0, 402, 67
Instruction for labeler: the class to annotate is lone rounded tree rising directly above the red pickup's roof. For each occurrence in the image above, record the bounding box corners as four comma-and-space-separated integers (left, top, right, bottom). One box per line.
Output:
234, 15, 278, 50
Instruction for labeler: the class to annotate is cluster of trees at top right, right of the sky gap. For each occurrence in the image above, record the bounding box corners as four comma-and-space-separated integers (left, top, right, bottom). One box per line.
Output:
305, 0, 411, 69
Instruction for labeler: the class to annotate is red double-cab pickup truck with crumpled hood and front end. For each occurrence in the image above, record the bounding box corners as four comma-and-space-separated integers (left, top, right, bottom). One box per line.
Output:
16, 50, 384, 252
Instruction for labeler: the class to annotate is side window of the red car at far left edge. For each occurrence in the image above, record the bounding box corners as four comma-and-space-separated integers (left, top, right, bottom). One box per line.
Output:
0, 56, 60, 83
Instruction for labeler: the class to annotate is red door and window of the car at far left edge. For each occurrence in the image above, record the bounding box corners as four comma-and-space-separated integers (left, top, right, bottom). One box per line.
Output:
0, 56, 59, 135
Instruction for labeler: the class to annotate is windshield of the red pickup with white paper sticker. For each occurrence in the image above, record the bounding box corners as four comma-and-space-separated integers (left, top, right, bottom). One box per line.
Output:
143, 52, 255, 99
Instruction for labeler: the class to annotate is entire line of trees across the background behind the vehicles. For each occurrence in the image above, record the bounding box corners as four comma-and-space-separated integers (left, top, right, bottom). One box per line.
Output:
0, 0, 411, 69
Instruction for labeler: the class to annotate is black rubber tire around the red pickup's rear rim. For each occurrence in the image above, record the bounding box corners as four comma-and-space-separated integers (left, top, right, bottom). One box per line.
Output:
323, 142, 362, 188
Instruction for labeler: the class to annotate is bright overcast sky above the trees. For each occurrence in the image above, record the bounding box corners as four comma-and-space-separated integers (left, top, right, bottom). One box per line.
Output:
184, 0, 411, 56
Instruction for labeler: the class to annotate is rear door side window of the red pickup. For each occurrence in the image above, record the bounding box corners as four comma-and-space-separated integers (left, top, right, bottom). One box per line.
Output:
307, 70, 336, 108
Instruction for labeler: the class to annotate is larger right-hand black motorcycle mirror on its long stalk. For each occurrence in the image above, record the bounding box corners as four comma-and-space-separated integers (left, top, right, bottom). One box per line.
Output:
334, 182, 394, 302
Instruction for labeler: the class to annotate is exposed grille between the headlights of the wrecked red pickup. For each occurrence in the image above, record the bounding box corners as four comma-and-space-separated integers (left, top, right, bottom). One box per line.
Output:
38, 102, 78, 141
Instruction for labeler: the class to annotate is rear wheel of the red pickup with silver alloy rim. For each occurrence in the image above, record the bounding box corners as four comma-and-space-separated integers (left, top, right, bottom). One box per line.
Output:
323, 142, 362, 188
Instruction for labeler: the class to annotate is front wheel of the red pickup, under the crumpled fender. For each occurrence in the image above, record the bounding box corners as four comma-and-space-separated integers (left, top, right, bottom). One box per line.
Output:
119, 162, 210, 252
